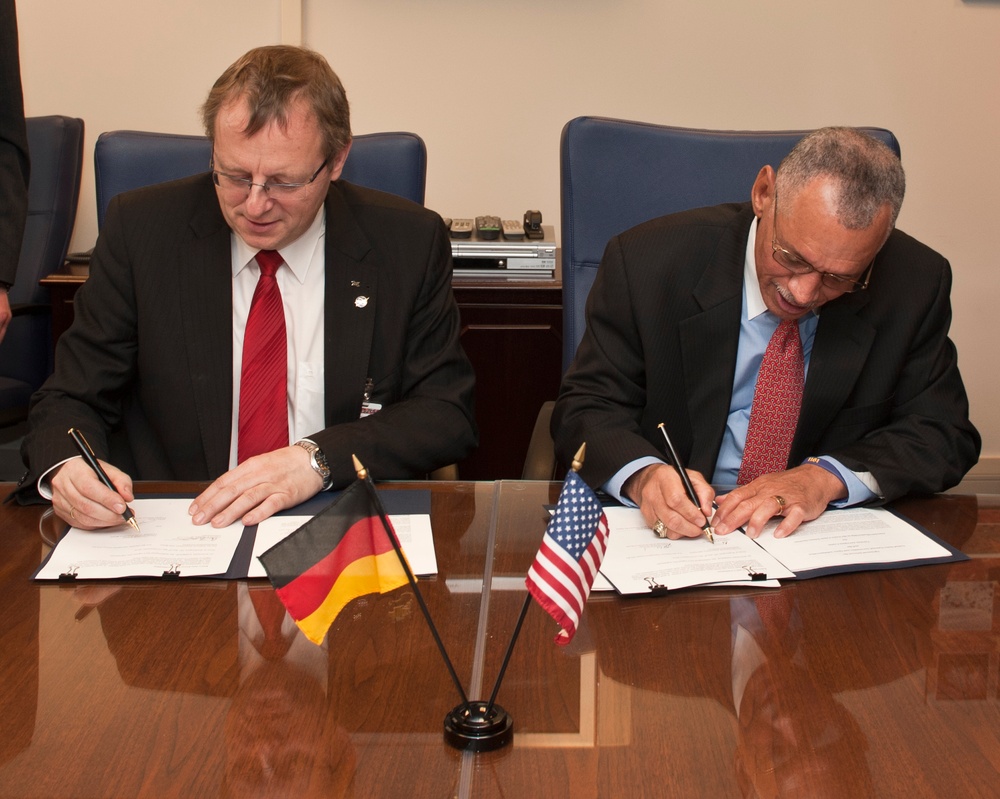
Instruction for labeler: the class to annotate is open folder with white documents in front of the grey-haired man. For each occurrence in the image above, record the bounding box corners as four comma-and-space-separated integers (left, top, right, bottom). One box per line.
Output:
601, 507, 968, 594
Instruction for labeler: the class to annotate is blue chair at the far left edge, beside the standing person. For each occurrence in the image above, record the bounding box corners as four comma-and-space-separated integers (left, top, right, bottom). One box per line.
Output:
0, 116, 83, 425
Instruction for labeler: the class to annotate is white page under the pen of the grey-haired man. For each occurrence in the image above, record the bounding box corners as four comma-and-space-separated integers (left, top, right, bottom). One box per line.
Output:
601, 507, 795, 594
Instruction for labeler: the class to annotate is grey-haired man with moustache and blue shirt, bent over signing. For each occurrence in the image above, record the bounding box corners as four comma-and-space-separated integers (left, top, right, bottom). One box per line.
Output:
552, 128, 980, 538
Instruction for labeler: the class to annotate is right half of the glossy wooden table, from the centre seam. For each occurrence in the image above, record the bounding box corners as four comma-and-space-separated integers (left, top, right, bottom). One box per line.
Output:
470, 483, 1000, 799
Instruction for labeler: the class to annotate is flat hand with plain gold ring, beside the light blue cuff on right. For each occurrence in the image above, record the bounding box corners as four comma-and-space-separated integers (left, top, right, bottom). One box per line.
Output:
712, 465, 847, 538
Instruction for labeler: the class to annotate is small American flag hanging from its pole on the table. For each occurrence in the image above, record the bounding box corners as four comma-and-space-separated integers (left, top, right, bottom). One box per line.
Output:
524, 472, 608, 646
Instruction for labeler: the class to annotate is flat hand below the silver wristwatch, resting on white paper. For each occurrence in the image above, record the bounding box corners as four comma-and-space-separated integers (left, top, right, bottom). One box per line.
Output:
188, 446, 323, 527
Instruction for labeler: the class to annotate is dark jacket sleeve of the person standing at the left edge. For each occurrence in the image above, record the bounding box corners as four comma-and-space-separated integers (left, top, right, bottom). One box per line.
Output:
0, 0, 28, 283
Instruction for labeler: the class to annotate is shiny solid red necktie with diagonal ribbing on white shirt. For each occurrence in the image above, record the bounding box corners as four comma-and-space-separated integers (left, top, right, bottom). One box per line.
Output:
237, 250, 288, 463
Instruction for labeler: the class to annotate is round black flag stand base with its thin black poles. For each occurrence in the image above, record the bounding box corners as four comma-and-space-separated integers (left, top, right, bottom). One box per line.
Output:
351, 455, 512, 752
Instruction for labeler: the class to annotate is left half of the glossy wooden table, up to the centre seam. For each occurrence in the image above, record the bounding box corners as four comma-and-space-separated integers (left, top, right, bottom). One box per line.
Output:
0, 483, 495, 799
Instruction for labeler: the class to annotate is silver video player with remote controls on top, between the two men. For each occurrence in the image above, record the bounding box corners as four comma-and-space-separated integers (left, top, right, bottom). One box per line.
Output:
444, 211, 556, 280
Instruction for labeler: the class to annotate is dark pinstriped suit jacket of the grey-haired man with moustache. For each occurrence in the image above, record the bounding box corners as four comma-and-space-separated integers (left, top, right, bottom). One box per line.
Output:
552, 204, 980, 499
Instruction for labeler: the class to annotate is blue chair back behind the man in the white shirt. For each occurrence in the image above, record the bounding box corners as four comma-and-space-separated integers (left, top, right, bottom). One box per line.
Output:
94, 130, 427, 227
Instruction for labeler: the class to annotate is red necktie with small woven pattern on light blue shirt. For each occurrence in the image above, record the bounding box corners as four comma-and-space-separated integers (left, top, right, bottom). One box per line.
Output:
736, 319, 805, 485
